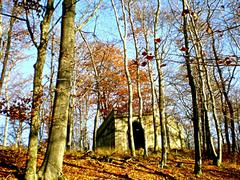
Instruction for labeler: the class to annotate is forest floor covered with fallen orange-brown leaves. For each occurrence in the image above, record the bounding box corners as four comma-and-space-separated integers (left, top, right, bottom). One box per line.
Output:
0, 147, 240, 180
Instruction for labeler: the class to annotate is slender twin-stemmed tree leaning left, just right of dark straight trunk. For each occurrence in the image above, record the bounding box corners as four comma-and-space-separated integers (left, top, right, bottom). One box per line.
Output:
187, 1, 222, 166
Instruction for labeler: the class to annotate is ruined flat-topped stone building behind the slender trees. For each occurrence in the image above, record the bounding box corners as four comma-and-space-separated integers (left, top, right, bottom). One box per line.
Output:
97, 111, 185, 151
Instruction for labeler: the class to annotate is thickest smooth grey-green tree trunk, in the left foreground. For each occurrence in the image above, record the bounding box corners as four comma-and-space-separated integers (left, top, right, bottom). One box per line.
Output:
39, 0, 76, 179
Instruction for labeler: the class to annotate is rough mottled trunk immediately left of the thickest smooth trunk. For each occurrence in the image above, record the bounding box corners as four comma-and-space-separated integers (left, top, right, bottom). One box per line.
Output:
25, 0, 53, 180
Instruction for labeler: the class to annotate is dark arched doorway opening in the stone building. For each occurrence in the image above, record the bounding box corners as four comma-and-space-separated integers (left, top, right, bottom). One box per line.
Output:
128, 121, 145, 150
